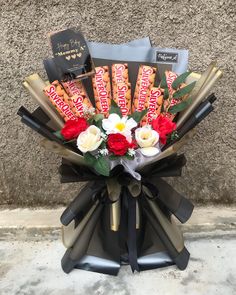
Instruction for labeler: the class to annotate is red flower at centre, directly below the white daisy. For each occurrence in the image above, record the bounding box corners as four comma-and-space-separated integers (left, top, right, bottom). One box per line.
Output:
107, 133, 133, 156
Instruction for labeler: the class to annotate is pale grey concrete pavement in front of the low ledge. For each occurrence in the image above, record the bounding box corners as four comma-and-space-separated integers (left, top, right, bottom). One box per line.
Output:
0, 233, 236, 295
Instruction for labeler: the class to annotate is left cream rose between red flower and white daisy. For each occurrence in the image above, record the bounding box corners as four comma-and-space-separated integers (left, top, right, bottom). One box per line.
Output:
77, 125, 103, 153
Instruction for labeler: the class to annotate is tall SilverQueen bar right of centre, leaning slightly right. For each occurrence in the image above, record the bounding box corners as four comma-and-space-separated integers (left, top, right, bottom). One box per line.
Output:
132, 65, 157, 112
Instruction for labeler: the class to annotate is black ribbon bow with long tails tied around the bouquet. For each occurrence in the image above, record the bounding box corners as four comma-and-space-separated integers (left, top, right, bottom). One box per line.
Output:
59, 155, 193, 272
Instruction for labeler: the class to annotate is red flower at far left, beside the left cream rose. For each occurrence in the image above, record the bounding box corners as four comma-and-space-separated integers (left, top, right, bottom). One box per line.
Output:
61, 118, 88, 140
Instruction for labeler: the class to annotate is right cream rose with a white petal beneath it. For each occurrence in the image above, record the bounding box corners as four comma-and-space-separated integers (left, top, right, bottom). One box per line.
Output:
135, 126, 160, 157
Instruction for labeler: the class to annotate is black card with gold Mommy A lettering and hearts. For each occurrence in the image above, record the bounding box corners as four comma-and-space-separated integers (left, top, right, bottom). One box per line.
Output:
50, 29, 93, 81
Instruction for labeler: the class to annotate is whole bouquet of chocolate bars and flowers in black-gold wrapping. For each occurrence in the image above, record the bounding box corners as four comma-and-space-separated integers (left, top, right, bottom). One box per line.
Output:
18, 29, 222, 275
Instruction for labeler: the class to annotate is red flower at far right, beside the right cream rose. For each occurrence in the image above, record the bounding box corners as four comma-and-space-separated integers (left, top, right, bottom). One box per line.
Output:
152, 115, 176, 144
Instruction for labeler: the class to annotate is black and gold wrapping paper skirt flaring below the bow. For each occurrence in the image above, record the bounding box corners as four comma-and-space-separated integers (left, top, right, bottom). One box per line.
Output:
60, 162, 193, 275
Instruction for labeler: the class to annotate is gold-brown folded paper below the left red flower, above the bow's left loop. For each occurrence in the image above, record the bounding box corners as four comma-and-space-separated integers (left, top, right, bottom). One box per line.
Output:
40, 138, 88, 166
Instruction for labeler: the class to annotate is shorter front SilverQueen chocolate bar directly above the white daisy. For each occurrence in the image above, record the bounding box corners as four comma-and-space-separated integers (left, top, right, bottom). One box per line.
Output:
113, 83, 131, 116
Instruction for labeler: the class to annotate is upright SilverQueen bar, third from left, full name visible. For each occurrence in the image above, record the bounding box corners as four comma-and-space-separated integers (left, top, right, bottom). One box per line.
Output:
92, 66, 111, 116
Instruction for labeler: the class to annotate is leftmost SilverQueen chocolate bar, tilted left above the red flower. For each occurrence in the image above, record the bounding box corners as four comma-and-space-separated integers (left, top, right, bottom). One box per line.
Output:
44, 81, 77, 122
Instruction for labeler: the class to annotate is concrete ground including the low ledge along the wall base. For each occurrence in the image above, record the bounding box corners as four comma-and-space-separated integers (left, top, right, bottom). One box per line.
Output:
0, 207, 236, 295
